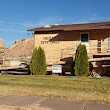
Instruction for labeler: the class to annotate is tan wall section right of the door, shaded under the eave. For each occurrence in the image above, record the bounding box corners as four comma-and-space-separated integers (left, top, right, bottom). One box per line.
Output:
90, 30, 109, 54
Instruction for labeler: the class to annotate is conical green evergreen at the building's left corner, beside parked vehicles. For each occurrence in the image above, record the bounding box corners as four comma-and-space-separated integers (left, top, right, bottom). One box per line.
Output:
29, 47, 46, 75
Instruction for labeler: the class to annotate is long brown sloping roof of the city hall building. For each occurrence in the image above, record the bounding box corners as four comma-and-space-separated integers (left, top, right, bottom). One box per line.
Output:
27, 22, 110, 32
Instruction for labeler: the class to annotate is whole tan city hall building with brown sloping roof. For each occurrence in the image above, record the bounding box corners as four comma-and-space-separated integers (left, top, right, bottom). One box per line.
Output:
28, 22, 110, 76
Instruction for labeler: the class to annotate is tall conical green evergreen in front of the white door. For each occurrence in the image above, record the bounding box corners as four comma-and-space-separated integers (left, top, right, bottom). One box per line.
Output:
74, 44, 89, 76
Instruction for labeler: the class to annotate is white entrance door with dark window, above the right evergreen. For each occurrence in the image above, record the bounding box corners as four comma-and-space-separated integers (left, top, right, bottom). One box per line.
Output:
80, 32, 89, 53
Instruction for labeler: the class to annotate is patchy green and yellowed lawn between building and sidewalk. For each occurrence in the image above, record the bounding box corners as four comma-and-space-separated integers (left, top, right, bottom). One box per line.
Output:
0, 75, 110, 103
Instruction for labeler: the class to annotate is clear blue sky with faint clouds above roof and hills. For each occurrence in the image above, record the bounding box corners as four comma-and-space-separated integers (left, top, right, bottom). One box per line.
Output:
0, 0, 110, 47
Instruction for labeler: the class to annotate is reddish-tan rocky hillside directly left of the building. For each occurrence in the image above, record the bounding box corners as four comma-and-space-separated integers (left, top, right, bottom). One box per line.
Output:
4, 38, 34, 61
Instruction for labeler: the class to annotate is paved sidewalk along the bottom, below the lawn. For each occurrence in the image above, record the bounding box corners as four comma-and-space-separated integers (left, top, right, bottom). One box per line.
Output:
0, 95, 110, 110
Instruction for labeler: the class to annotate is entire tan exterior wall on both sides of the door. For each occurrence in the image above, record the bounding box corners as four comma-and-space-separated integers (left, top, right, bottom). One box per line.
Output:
34, 30, 109, 63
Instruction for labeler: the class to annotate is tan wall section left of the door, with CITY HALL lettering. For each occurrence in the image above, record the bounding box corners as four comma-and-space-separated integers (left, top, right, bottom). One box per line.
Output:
34, 31, 80, 64
